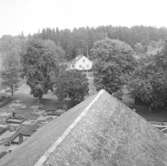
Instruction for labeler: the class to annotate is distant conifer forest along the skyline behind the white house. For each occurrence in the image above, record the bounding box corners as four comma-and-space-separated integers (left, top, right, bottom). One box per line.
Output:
32, 26, 167, 59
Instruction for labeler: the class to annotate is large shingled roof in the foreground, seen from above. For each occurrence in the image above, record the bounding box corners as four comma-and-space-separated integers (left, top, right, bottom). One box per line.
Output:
0, 90, 167, 166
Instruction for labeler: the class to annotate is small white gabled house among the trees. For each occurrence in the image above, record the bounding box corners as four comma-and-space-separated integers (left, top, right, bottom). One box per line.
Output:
69, 55, 93, 71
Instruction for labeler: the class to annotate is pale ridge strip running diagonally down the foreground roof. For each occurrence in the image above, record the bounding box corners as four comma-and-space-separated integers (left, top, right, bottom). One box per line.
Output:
34, 89, 105, 166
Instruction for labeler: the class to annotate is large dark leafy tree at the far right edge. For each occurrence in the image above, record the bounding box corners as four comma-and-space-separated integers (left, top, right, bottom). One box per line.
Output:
129, 40, 167, 110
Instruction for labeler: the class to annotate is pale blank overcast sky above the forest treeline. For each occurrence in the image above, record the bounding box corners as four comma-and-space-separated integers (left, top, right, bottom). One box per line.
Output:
0, 0, 167, 36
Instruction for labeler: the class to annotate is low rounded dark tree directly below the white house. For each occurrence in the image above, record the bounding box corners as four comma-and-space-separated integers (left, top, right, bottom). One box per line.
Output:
55, 70, 89, 108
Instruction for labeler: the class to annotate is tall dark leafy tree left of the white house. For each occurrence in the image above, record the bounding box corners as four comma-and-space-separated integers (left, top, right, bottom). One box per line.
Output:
22, 39, 61, 99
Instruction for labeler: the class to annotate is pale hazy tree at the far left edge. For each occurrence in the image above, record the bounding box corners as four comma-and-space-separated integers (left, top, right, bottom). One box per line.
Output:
0, 36, 24, 96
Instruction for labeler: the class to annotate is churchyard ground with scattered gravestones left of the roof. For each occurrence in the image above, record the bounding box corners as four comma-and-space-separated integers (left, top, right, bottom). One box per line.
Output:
0, 85, 64, 157
